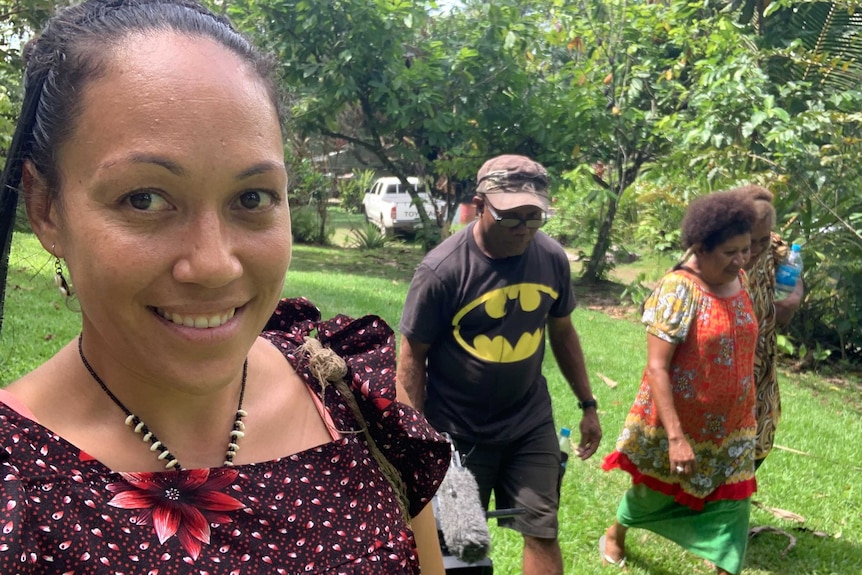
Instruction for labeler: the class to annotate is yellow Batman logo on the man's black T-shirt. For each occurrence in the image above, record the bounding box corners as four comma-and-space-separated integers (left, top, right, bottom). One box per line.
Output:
452, 283, 558, 363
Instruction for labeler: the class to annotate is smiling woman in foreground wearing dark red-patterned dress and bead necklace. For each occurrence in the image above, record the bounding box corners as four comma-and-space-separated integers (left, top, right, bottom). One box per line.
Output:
0, 0, 449, 574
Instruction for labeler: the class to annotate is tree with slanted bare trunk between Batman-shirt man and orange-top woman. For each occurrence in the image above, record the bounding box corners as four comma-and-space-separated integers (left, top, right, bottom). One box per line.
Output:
546, 0, 704, 281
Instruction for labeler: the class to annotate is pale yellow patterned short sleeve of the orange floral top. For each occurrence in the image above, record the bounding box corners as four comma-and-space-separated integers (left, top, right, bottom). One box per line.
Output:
641, 272, 700, 344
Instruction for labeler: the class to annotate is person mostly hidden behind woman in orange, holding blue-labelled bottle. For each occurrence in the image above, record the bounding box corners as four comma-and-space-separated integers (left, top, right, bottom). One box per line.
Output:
736, 185, 804, 469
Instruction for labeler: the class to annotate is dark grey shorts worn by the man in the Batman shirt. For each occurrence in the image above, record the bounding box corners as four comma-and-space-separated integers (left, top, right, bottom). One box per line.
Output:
455, 424, 562, 539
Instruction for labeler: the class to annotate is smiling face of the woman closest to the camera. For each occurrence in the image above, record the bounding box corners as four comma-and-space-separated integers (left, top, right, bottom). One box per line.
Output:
29, 32, 291, 385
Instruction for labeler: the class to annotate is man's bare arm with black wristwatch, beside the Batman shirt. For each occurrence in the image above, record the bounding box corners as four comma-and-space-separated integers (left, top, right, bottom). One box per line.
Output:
548, 316, 602, 459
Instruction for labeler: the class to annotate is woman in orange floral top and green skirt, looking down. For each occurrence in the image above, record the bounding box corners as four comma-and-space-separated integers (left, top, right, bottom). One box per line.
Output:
599, 192, 757, 575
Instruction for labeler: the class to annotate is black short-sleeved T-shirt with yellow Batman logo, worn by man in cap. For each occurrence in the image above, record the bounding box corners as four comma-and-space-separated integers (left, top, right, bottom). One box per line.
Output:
399, 223, 575, 443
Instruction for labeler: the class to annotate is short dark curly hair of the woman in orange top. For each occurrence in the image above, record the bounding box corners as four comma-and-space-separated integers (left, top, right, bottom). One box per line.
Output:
682, 190, 757, 252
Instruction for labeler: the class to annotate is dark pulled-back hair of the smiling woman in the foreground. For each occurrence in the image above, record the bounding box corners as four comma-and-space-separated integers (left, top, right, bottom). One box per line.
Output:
0, 0, 281, 327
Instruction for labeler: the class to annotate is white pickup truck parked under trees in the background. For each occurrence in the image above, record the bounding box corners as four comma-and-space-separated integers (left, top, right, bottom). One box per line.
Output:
362, 177, 444, 235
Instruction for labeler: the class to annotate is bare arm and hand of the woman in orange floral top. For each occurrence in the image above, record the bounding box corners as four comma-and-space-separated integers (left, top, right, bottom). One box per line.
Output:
646, 334, 696, 474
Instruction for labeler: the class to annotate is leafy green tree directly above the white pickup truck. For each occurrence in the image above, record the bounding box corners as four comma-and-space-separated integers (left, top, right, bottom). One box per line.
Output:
228, 0, 584, 245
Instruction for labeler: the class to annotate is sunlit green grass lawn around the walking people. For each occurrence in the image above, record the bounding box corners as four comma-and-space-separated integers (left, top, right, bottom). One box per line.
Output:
0, 234, 862, 575
